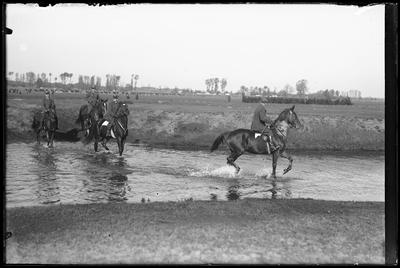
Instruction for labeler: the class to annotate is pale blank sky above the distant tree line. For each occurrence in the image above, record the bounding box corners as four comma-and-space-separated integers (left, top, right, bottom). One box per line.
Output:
6, 4, 385, 97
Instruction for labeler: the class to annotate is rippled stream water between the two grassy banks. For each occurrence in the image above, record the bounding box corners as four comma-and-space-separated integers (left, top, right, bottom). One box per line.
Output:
6, 142, 385, 207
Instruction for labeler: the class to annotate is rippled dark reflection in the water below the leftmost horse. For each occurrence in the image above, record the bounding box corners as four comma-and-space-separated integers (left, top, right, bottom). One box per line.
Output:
30, 148, 61, 204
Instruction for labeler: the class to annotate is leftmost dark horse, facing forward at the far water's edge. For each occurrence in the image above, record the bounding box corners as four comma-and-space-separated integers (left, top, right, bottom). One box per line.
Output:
32, 111, 56, 147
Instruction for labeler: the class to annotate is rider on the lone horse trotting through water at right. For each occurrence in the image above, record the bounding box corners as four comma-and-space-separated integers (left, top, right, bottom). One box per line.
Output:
251, 98, 279, 153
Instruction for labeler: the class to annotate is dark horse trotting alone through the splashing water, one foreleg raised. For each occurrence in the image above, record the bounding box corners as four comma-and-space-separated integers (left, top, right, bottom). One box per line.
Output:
211, 105, 302, 178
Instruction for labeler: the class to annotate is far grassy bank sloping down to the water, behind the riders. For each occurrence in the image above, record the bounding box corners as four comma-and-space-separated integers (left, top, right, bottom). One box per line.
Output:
7, 94, 385, 150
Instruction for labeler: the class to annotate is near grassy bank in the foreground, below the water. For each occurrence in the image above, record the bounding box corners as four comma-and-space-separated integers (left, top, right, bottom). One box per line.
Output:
6, 199, 385, 264
